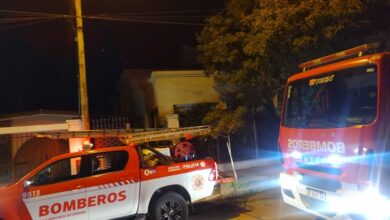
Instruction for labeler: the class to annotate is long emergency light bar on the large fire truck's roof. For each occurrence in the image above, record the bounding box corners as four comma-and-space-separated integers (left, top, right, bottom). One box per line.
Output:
299, 42, 380, 71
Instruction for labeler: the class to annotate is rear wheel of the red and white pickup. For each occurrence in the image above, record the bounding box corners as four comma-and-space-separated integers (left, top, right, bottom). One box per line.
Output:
151, 192, 188, 220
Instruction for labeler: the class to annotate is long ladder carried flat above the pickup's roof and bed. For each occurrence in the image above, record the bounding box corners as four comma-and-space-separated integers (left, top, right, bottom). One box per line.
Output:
35, 125, 211, 145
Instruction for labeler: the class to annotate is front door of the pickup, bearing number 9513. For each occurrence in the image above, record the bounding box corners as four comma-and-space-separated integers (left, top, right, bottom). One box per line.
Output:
21, 156, 88, 219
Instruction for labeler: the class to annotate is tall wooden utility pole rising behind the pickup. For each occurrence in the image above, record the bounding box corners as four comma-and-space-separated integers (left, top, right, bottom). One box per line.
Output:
75, 0, 89, 130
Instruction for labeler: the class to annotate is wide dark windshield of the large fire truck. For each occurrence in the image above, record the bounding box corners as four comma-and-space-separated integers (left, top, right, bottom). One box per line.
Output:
283, 65, 378, 128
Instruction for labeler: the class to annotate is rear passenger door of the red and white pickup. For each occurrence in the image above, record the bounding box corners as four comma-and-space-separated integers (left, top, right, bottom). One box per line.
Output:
86, 150, 139, 219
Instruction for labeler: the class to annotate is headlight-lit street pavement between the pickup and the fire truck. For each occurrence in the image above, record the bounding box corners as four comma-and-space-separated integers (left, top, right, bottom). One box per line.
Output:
190, 160, 316, 220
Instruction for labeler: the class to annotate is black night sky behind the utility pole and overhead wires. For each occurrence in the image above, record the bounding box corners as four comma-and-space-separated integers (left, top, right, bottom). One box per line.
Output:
0, 0, 225, 117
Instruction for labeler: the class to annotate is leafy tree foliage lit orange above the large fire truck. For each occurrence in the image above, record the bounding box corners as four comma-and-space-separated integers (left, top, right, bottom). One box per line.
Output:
197, 0, 389, 132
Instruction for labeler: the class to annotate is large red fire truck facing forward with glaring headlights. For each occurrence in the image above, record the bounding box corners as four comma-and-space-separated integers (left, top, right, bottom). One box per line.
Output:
278, 43, 390, 219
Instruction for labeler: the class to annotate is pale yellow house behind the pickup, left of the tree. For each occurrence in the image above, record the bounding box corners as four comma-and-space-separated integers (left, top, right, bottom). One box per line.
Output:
116, 69, 219, 128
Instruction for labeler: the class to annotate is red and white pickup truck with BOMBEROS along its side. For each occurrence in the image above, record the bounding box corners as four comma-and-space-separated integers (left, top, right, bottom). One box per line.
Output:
0, 146, 218, 220
